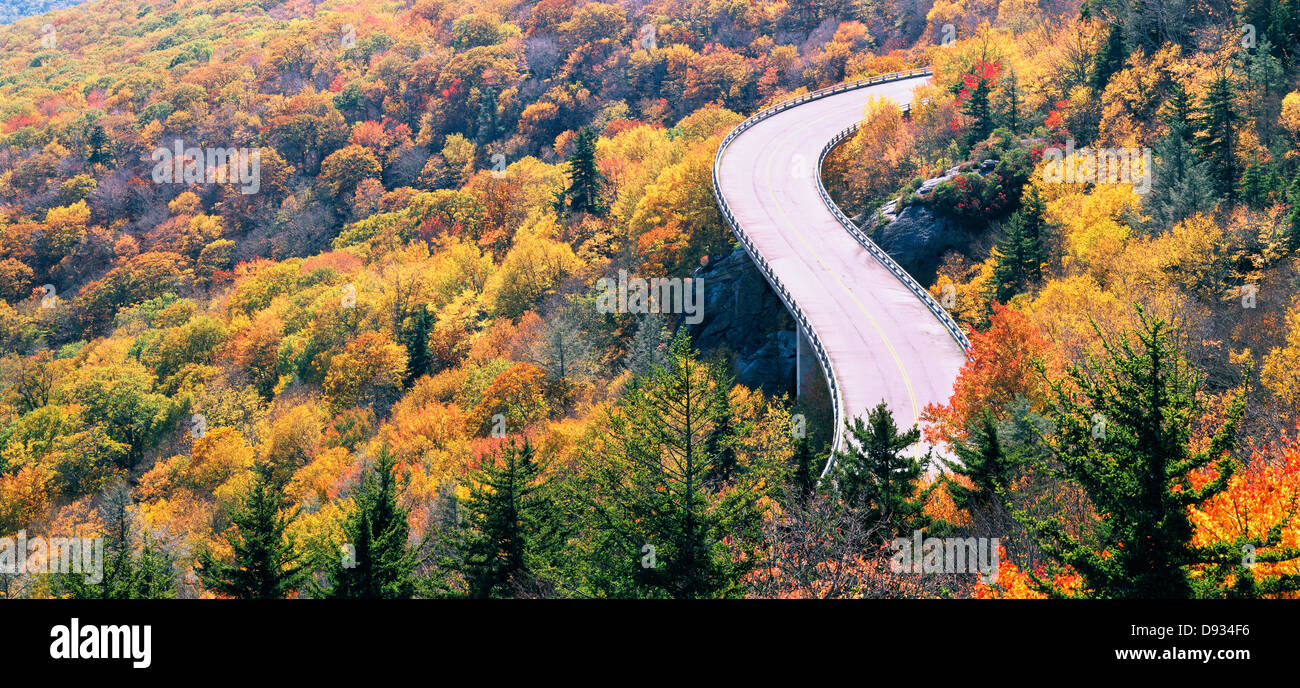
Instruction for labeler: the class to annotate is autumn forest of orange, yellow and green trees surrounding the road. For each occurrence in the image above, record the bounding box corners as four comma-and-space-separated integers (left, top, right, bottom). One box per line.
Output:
0, 0, 1300, 597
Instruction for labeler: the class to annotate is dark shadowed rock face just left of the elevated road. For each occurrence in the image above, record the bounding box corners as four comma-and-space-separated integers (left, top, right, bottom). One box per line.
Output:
688, 248, 797, 397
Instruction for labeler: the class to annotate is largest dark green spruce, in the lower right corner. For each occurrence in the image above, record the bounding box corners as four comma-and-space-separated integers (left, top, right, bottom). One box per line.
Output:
1015, 308, 1300, 598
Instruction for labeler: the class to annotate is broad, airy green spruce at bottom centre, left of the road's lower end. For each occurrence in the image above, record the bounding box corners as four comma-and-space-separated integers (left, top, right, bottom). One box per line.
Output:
569, 333, 764, 598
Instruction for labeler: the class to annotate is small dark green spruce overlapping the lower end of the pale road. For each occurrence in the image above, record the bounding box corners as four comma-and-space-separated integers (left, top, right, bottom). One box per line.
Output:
832, 401, 931, 541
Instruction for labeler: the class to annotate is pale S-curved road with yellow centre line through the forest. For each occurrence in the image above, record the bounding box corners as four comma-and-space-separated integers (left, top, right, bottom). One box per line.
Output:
714, 69, 969, 475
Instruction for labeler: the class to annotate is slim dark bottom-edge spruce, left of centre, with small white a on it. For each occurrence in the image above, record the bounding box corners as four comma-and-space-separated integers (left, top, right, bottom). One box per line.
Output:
324, 447, 423, 600
